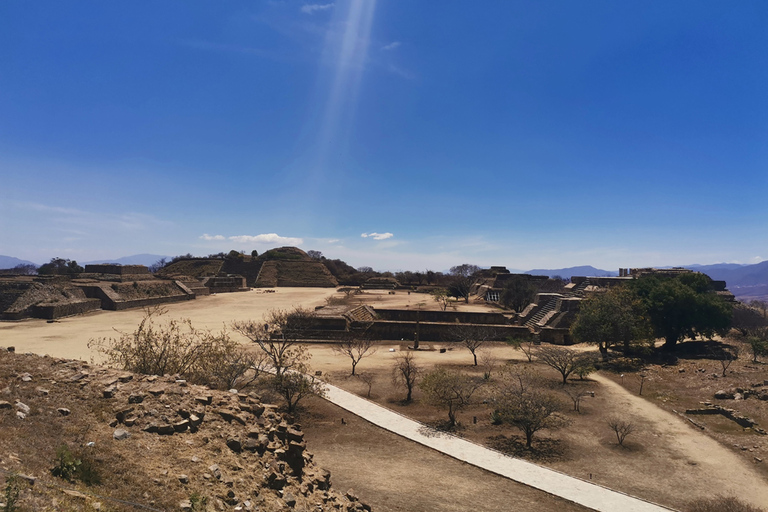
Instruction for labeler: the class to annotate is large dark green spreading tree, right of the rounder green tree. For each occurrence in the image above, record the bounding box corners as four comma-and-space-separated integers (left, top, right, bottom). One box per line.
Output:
629, 272, 732, 349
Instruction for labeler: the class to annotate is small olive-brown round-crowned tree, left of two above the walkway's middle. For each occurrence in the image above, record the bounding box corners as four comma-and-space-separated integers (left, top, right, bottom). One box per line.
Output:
419, 366, 482, 427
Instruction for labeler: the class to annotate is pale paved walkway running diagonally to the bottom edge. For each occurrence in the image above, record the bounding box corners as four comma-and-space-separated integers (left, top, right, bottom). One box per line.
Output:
318, 384, 670, 512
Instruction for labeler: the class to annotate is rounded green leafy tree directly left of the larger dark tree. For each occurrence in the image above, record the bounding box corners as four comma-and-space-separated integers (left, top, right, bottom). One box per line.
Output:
571, 286, 652, 359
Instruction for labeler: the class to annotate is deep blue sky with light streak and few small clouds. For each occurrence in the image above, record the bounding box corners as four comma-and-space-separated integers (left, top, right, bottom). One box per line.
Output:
0, 0, 768, 271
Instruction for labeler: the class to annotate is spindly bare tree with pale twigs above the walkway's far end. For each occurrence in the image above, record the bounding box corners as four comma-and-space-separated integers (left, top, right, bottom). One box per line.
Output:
232, 307, 314, 377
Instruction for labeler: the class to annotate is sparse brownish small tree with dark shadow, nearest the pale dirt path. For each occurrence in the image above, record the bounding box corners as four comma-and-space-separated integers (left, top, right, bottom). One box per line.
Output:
490, 371, 568, 448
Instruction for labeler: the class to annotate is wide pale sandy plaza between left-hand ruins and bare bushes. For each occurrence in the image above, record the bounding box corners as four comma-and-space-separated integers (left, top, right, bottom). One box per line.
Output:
0, 288, 335, 360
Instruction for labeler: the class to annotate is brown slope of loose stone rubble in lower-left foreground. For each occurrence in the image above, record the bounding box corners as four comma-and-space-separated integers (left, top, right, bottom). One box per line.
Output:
0, 355, 371, 511
